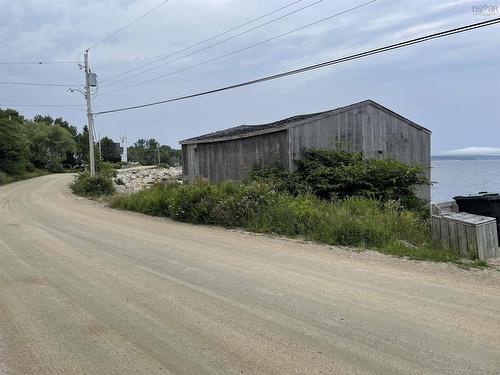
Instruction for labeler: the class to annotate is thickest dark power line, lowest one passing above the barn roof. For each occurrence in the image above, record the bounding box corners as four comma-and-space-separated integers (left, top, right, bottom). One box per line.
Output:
94, 17, 500, 115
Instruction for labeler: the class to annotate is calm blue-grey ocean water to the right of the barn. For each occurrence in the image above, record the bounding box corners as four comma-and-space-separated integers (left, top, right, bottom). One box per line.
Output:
431, 157, 500, 202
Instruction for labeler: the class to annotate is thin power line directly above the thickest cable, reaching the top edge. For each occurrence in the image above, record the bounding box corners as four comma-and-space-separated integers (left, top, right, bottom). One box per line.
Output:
102, 0, 377, 95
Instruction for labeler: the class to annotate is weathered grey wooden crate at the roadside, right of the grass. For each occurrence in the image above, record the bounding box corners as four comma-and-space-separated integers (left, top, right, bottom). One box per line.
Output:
432, 212, 500, 260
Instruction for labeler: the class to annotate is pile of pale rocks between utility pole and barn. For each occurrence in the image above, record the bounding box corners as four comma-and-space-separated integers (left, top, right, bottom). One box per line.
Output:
113, 167, 182, 193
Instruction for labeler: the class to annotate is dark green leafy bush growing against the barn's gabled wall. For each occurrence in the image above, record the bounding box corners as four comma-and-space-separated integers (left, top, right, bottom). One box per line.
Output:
248, 149, 429, 211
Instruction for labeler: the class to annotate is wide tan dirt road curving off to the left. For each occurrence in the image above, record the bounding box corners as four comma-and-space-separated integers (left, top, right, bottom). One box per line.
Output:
0, 175, 500, 375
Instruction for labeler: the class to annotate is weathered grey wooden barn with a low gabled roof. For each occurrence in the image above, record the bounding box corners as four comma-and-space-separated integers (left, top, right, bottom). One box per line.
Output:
179, 100, 431, 201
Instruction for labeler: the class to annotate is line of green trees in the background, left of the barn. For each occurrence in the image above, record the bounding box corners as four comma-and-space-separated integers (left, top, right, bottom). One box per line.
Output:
0, 109, 180, 180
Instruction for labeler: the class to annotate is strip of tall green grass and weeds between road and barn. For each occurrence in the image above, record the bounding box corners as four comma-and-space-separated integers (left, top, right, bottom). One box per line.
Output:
111, 182, 429, 253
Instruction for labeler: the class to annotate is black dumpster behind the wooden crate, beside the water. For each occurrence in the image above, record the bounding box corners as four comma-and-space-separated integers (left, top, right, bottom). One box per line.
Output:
453, 192, 500, 244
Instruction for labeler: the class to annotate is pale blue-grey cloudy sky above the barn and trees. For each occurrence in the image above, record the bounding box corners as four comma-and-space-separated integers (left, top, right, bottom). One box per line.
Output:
0, 0, 500, 155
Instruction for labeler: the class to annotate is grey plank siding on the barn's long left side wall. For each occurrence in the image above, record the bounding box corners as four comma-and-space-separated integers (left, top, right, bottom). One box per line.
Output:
182, 129, 289, 182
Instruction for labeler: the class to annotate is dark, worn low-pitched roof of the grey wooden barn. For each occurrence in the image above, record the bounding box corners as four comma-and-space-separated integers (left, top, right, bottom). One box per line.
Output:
179, 100, 430, 144
